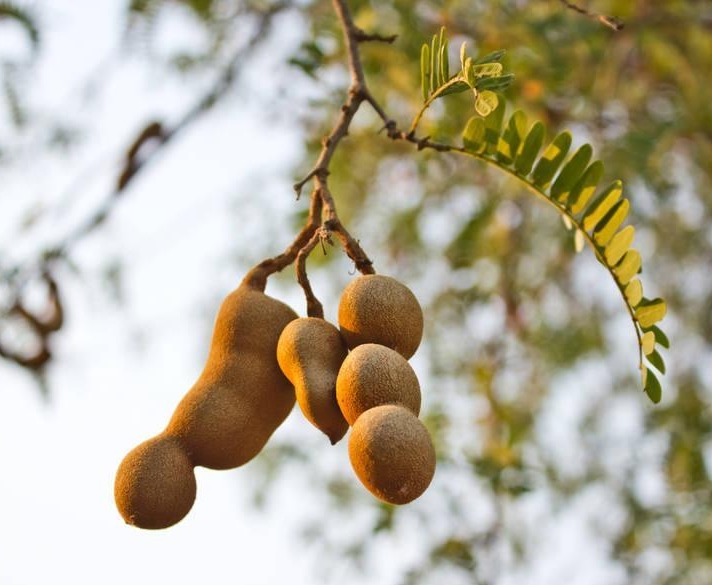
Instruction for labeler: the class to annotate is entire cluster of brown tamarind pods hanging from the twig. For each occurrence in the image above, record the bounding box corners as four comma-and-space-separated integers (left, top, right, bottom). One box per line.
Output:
114, 275, 435, 528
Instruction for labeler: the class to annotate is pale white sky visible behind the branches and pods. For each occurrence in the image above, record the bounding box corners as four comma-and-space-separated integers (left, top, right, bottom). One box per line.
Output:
0, 0, 660, 585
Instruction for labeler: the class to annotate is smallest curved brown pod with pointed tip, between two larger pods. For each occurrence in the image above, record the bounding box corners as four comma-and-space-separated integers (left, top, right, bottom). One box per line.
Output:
277, 317, 349, 445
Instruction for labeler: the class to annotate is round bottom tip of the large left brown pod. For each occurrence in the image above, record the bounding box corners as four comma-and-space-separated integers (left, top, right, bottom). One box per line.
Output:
114, 434, 196, 529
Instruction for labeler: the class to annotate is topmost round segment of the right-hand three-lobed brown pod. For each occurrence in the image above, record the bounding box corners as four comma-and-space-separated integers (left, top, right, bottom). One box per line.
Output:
339, 274, 423, 359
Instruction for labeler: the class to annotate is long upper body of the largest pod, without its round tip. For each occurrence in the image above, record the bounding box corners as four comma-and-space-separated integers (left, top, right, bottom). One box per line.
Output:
166, 284, 297, 469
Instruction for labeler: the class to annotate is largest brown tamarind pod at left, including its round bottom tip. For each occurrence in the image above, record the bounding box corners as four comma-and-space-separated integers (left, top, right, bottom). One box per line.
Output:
114, 284, 297, 528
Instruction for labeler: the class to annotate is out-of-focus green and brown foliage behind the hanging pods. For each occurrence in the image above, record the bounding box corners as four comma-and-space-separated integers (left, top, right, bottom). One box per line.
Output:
0, 0, 712, 584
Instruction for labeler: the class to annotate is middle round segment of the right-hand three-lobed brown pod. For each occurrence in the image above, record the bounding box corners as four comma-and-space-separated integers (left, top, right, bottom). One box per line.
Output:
336, 343, 420, 425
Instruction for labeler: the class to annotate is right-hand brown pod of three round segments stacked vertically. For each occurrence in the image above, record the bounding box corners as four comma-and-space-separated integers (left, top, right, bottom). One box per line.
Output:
336, 275, 435, 504
